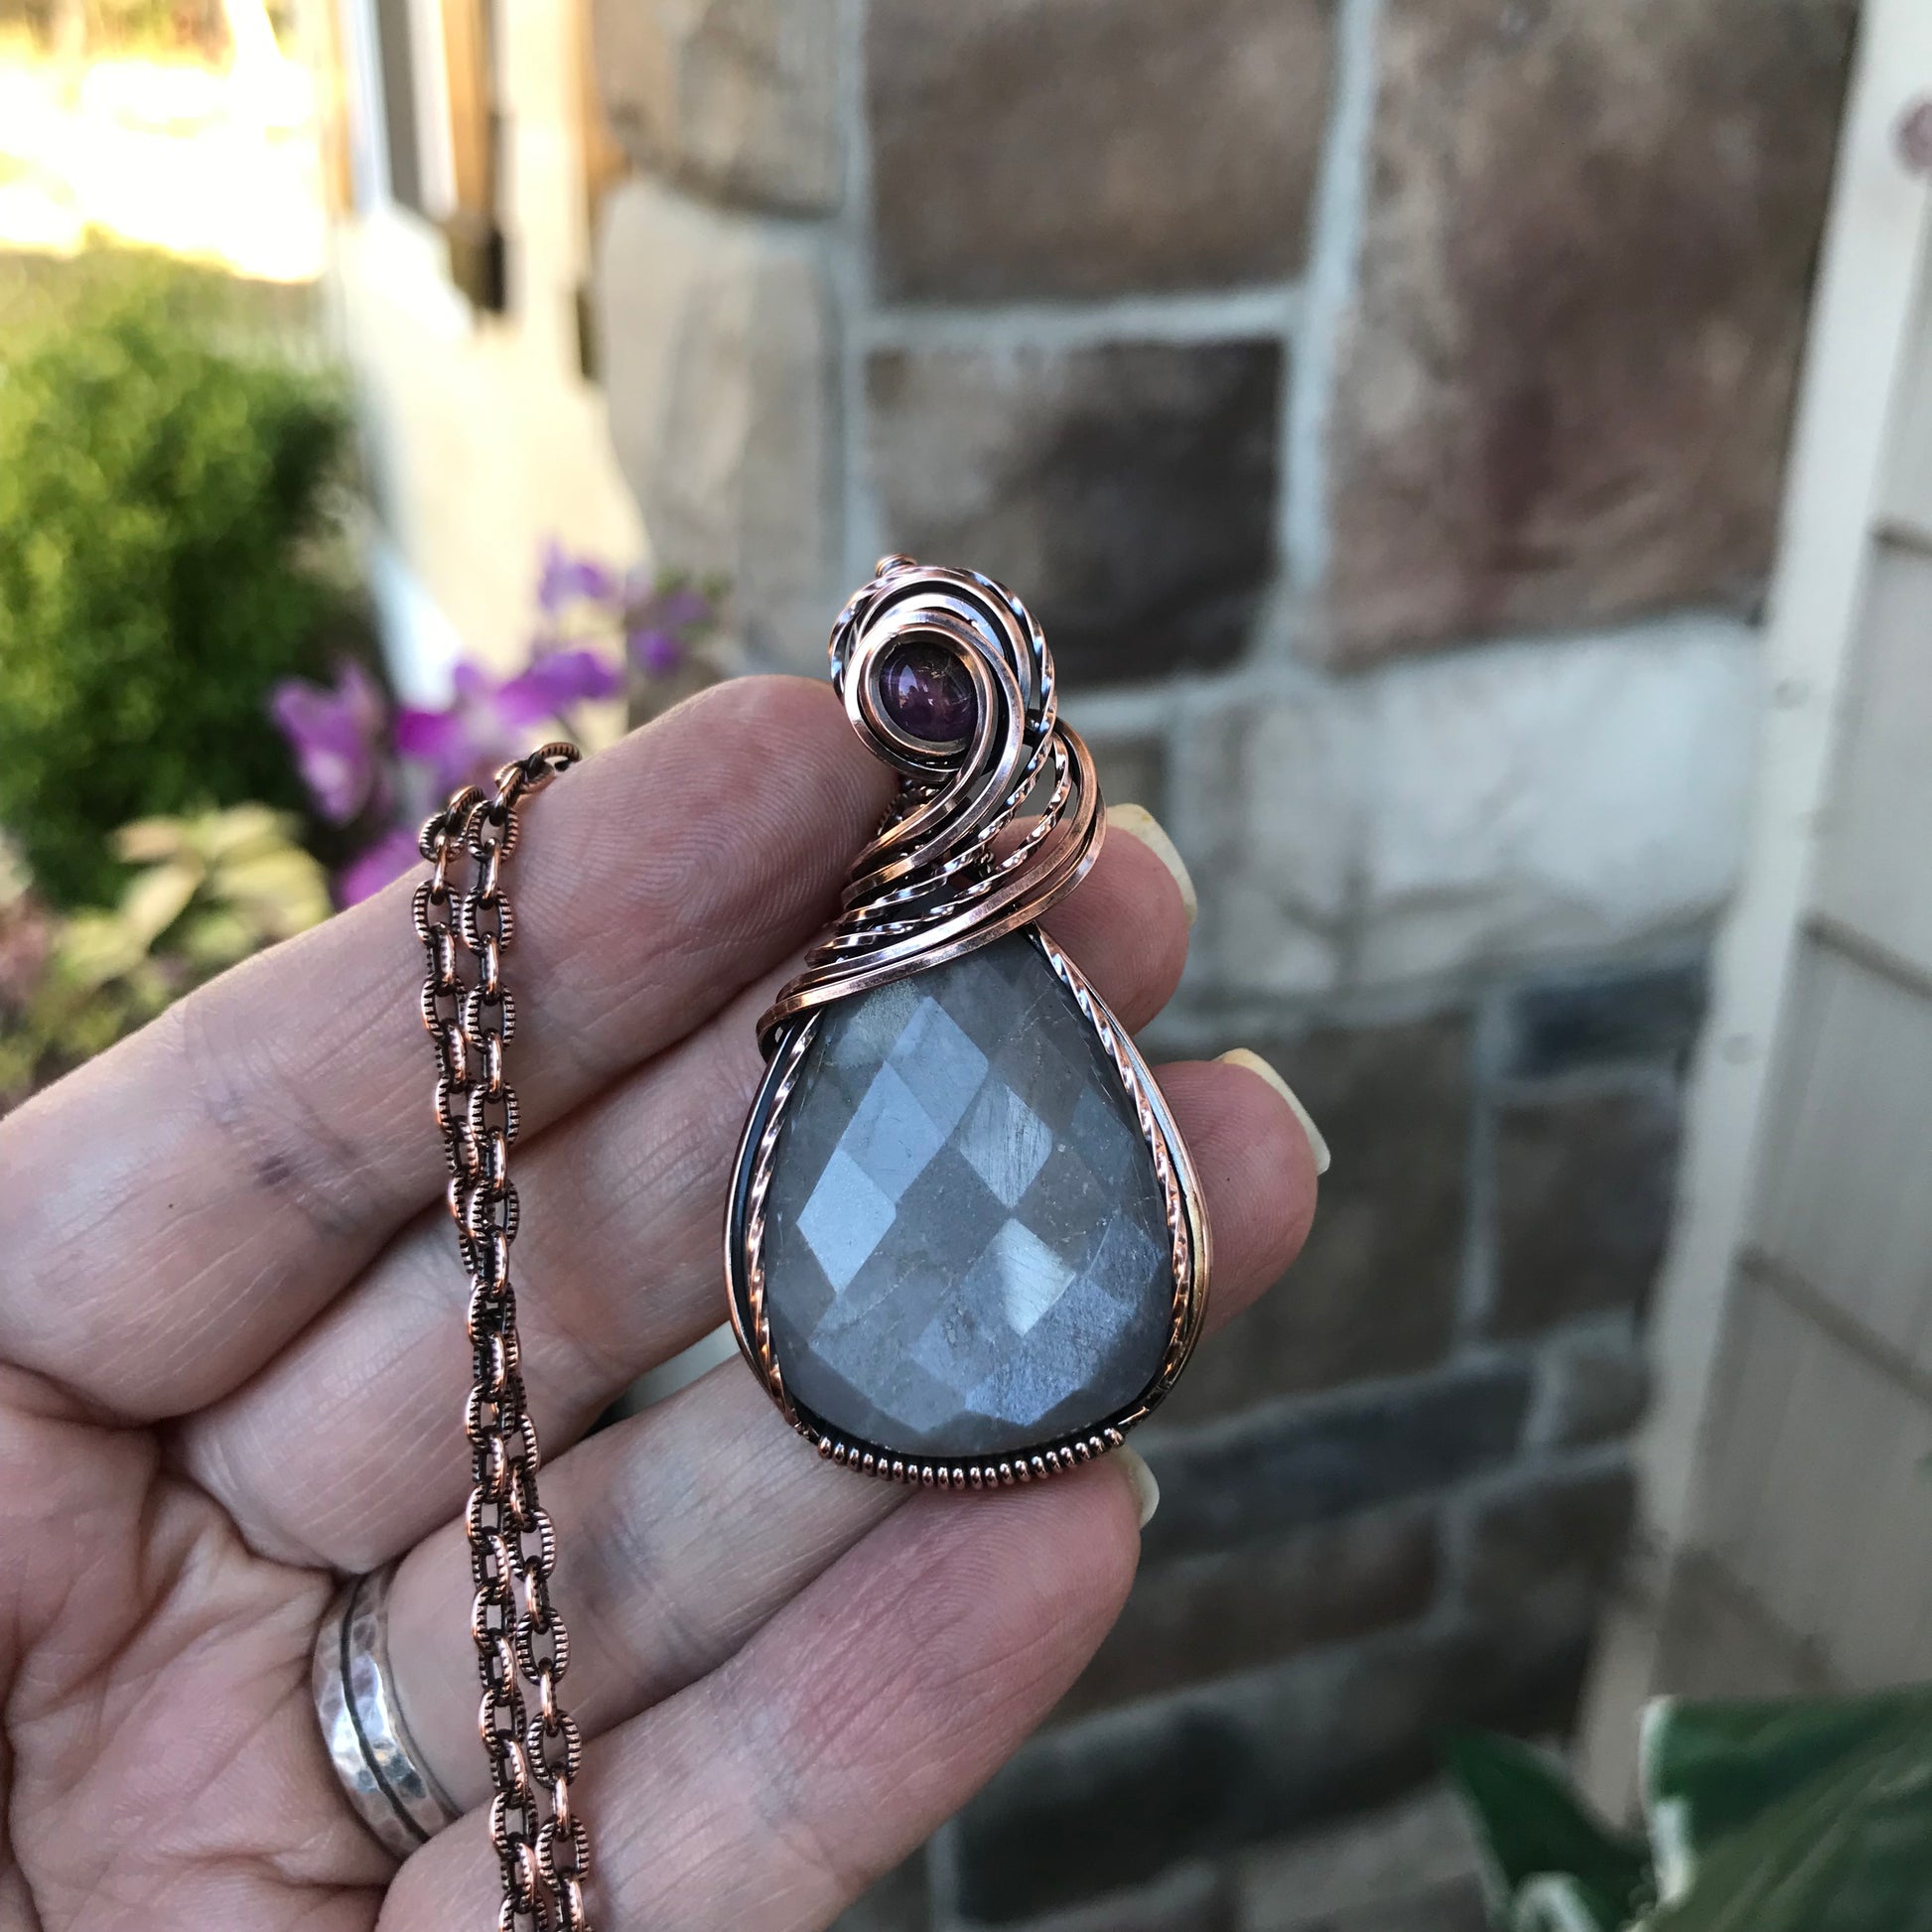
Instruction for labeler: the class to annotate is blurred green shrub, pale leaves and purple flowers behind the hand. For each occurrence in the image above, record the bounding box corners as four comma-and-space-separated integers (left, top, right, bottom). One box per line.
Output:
0, 239, 723, 1109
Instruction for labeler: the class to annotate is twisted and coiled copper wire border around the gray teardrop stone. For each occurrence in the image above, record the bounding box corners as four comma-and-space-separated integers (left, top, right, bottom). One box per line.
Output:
725, 927, 1211, 1489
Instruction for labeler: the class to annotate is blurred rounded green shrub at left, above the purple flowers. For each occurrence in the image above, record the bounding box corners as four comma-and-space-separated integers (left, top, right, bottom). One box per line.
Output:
0, 249, 347, 904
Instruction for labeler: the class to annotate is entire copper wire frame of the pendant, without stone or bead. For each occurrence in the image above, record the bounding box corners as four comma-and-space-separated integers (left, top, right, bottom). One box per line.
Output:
725, 556, 1211, 1489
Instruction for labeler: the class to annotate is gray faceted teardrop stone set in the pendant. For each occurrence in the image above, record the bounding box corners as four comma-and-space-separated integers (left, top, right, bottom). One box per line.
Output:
765, 933, 1174, 1458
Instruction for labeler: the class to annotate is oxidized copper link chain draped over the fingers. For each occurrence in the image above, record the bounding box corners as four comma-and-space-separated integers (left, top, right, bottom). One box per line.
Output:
415, 740, 590, 1932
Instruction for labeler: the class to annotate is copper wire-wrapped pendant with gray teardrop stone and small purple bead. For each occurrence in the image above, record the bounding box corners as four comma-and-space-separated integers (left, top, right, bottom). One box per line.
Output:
725, 556, 1209, 1489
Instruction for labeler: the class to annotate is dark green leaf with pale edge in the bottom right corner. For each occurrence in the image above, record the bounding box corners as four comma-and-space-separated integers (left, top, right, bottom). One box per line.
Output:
1642, 1689, 1932, 1932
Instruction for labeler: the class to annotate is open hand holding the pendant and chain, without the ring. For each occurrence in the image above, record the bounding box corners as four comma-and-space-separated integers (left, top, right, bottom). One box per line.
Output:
0, 680, 1313, 1932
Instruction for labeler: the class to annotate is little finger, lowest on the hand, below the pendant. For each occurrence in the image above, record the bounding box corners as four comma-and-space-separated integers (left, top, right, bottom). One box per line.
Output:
382, 1464, 1136, 1932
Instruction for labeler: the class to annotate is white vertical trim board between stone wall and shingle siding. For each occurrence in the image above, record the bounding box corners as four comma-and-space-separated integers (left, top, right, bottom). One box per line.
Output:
1579, 0, 1932, 1810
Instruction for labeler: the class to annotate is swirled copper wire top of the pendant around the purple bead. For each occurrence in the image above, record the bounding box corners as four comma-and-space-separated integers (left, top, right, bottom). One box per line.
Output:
758, 556, 1105, 1055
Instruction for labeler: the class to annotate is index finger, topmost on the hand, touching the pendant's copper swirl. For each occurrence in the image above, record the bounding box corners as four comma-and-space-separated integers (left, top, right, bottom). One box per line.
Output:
0, 678, 891, 1420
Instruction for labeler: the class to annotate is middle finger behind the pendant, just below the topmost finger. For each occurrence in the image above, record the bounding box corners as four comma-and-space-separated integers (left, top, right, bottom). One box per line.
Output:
178, 839, 1186, 1571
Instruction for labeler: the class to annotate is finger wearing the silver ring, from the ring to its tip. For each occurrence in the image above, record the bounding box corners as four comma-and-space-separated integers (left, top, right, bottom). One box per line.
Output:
374, 1064, 1313, 1803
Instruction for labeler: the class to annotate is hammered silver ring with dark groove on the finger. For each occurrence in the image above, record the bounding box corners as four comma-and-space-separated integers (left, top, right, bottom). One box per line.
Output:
311, 1563, 462, 1859
